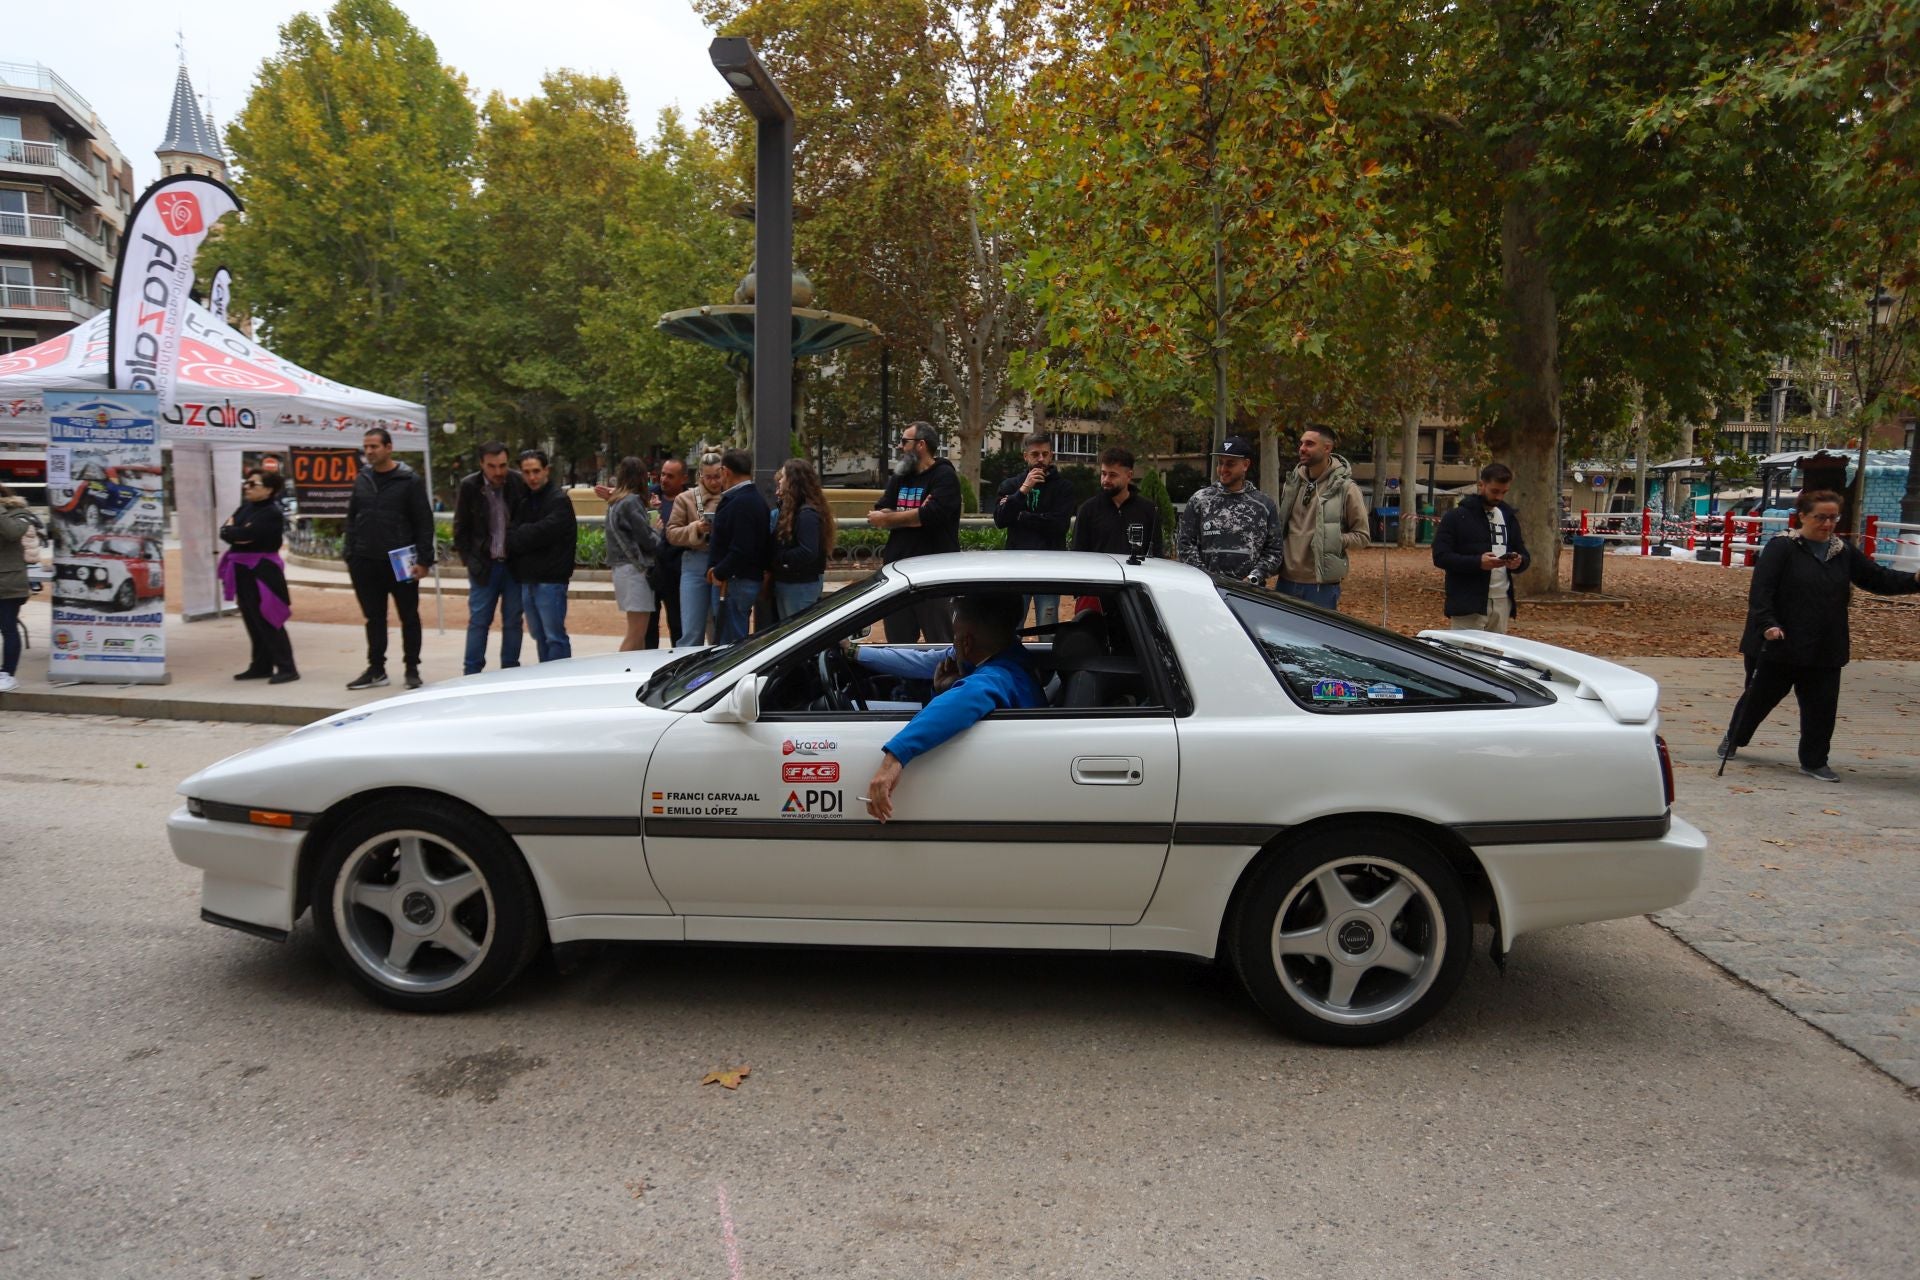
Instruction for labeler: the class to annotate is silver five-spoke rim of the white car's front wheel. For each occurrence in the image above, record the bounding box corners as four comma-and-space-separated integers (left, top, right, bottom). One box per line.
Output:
334, 831, 495, 994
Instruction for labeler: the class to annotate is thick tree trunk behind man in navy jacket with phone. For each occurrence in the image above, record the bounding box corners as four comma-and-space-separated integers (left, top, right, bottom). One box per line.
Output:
1500, 192, 1561, 597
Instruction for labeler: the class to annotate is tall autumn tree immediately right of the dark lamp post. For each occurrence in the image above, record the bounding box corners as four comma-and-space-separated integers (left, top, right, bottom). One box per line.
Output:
693, 0, 1043, 482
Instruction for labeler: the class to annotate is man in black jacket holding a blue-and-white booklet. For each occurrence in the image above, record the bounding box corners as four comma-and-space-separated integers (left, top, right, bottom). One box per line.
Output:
346, 426, 434, 689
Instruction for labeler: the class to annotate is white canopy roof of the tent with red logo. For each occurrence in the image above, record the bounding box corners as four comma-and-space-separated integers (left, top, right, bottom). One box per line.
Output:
0, 303, 426, 449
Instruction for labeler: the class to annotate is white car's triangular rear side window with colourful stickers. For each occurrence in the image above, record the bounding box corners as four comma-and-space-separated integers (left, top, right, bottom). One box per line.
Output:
1223, 591, 1544, 714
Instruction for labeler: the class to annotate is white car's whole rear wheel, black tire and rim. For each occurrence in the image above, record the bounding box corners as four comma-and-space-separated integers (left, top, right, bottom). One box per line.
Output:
1227, 823, 1473, 1044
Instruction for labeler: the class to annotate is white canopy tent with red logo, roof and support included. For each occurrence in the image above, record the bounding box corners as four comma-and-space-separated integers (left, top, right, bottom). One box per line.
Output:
0, 301, 438, 620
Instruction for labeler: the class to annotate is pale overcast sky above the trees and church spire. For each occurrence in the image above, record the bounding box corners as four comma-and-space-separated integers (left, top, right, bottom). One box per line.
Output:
0, 0, 726, 188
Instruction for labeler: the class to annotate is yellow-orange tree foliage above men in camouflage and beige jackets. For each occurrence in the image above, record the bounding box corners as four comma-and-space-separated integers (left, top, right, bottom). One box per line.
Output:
998, 0, 1419, 458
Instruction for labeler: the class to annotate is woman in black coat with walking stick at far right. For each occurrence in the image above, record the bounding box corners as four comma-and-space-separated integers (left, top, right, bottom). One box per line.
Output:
1718, 489, 1920, 783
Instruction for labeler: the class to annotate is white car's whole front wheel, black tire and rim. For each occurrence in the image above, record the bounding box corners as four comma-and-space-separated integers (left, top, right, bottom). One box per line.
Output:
311, 798, 545, 1013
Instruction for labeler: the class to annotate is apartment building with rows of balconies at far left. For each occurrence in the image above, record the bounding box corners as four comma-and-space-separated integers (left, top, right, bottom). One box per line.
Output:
0, 61, 134, 355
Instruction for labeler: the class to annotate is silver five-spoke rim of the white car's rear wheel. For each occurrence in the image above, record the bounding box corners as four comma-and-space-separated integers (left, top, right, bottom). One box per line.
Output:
1271, 856, 1448, 1027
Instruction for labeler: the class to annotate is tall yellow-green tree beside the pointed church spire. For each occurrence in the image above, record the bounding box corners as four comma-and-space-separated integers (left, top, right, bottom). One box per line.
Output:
223, 0, 474, 391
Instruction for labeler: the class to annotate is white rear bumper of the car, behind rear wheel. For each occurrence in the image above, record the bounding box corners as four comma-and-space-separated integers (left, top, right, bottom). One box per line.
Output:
1473, 818, 1707, 948
